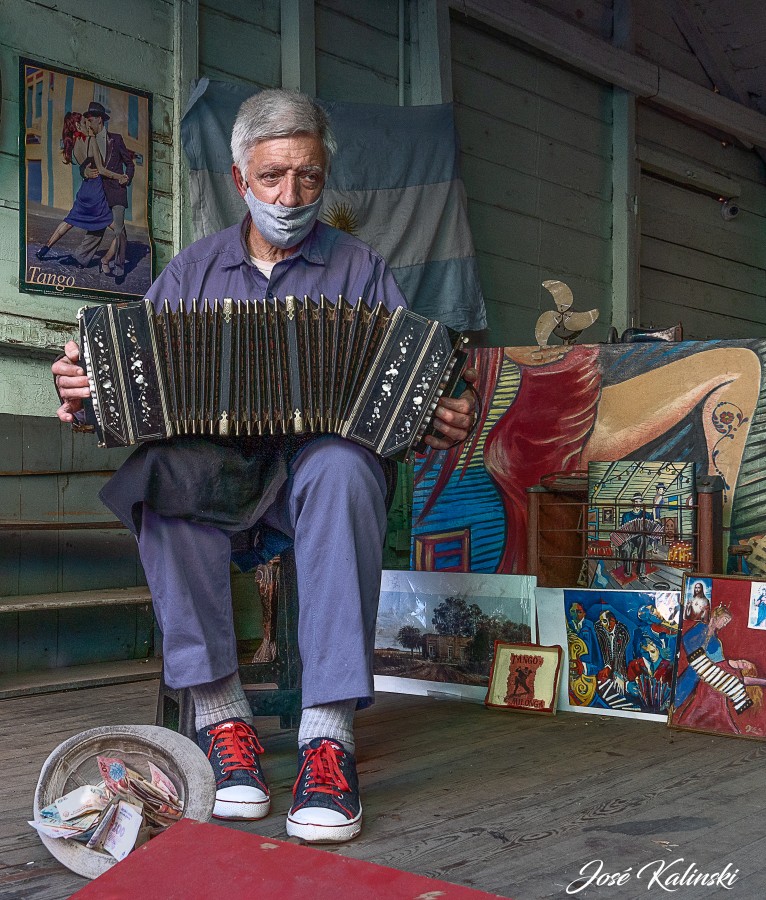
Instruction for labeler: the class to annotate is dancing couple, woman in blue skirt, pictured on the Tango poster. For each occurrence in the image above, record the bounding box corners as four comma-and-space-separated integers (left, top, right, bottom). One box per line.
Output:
35, 101, 135, 284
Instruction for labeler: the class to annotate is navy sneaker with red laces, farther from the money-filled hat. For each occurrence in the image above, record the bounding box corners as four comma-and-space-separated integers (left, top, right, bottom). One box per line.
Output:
287, 738, 362, 843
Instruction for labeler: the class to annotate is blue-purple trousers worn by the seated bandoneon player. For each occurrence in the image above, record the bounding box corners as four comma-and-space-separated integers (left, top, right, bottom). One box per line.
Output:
139, 436, 387, 707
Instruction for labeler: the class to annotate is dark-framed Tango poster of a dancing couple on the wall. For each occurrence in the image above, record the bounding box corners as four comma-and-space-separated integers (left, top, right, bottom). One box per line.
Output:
19, 59, 153, 300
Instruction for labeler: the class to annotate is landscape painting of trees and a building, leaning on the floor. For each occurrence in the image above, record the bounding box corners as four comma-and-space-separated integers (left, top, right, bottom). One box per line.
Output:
374, 571, 535, 700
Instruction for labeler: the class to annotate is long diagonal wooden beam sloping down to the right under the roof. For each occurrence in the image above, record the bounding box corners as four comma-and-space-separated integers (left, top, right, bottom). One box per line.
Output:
449, 0, 766, 147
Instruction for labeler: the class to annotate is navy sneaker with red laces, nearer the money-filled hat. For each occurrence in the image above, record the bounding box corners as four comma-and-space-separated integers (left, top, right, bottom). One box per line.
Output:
197, 719, 271, 821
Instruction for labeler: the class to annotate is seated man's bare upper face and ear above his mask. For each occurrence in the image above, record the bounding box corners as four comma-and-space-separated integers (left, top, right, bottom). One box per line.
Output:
237, 134, 326, 207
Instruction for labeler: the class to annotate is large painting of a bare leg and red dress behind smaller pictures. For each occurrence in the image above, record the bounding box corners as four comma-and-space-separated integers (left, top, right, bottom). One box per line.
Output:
412, 340, 766, 575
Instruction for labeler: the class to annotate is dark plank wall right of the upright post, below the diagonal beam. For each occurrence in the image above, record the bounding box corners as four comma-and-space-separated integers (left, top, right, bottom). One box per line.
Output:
637, 105, 766, 340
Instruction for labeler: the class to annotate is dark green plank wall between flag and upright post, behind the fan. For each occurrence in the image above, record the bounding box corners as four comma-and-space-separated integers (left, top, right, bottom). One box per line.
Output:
451, 17, 612, 345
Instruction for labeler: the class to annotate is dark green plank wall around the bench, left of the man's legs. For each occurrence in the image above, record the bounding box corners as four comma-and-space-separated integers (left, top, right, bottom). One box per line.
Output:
0, 415, 154, 675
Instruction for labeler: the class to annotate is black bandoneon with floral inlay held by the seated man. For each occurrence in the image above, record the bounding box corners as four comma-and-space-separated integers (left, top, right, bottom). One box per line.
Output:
78, 297, 466, 458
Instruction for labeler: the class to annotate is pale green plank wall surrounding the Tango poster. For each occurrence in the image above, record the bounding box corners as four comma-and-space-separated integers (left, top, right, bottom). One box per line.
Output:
0, 0, 173, 415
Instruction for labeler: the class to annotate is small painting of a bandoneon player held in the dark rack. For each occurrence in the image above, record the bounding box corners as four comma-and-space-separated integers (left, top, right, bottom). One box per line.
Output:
587, 460, 698, 591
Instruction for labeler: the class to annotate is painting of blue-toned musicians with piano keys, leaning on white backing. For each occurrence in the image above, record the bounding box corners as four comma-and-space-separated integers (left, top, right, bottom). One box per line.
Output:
564, 590, 681, 717
